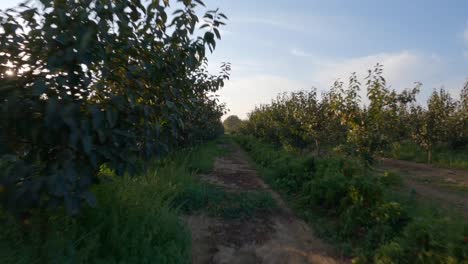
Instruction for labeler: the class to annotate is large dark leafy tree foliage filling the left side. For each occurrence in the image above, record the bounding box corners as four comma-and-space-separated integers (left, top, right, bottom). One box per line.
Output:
0, 0, 230, 215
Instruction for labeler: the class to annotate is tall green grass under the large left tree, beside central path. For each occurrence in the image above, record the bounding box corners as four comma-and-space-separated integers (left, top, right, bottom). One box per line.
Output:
0, 141, 229, 264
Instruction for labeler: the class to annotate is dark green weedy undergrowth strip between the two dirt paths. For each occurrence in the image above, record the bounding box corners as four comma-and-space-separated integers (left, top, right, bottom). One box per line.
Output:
236, 136, 468, 263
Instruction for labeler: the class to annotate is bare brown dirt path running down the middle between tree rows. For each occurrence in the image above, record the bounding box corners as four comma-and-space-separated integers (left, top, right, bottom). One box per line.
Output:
187, 146, 345, 264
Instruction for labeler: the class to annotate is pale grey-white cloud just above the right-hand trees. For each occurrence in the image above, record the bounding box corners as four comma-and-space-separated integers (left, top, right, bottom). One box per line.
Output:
311, 51, 468, 103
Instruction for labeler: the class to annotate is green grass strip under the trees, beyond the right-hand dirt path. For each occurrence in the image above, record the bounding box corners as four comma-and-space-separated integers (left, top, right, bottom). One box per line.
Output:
386, 142, 468, 170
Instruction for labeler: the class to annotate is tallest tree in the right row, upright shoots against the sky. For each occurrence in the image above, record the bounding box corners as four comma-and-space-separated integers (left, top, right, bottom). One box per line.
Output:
346, 64, 419, 161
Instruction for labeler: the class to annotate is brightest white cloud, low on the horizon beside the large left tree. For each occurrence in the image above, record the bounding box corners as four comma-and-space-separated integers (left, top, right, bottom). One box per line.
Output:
219, 75, 308, 118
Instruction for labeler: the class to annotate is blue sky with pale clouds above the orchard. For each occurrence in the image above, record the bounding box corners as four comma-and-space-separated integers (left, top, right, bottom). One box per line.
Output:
0, 0, 468, 118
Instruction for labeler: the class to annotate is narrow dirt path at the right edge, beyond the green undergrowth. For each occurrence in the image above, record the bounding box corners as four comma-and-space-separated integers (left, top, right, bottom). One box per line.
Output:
380, 159, 468, 218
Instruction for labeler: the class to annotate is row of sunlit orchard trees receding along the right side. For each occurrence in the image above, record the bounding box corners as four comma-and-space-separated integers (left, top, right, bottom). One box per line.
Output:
241, 65, 468, 162
